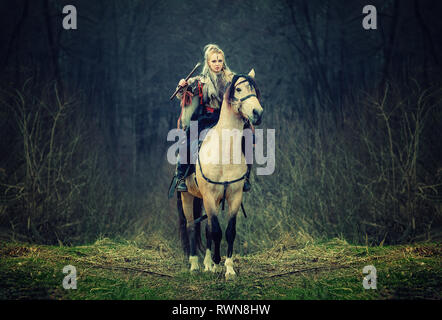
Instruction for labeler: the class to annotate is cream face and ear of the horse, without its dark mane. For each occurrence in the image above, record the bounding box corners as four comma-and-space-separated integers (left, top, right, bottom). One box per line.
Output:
232, 69, 264, 125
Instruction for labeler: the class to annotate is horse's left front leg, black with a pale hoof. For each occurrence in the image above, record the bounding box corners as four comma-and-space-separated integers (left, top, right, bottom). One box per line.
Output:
204, 197, 223, 272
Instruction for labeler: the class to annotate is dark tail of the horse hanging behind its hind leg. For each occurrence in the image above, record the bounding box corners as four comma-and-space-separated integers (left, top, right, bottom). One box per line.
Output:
177, 191, 203, 256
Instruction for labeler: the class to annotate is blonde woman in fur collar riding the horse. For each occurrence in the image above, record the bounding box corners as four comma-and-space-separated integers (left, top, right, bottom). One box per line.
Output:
176, 44, 250, 192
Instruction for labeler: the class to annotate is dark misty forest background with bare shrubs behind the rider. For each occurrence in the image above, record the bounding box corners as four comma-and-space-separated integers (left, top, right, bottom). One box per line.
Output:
0, 0, 442, 252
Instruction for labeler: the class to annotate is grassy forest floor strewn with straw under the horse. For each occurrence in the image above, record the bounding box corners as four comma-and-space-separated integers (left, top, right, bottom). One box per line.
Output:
0, 238, 442, 300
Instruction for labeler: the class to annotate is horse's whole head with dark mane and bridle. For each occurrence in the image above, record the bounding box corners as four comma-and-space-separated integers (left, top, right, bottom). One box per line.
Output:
226, 69, 264, 125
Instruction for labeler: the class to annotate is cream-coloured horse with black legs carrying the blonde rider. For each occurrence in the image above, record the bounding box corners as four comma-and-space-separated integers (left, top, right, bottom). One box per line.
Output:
177, 69, 263, 279
